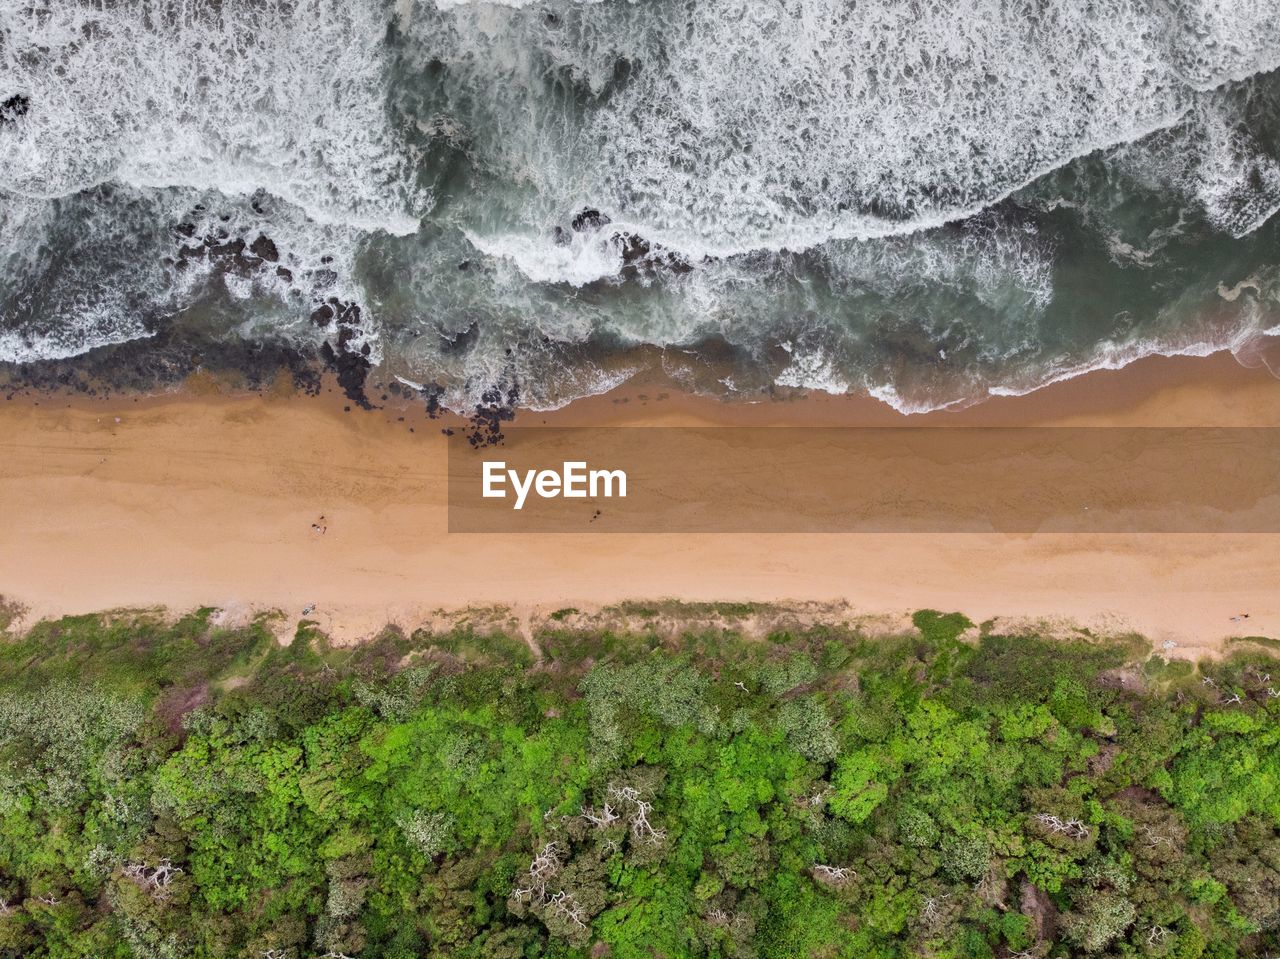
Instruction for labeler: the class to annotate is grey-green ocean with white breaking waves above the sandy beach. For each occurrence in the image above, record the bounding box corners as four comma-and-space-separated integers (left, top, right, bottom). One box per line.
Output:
0, 0, 1280, 411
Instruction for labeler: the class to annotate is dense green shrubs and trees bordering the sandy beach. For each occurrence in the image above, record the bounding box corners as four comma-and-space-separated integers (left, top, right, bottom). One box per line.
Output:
0, 611, 1280, 959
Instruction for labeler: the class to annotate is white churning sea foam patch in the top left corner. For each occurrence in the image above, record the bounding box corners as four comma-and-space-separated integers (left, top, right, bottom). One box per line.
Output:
0, 0, 430, 232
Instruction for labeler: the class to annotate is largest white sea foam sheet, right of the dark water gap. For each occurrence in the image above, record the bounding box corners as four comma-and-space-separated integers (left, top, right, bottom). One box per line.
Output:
413, 0, 1280, 265
